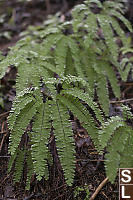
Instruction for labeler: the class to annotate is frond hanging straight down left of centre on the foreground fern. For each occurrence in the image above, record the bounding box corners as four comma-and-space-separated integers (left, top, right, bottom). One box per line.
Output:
31, 101, 51, 180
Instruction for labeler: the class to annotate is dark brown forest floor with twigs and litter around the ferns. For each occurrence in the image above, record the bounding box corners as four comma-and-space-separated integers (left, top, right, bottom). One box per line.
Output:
0, 0, 133, 200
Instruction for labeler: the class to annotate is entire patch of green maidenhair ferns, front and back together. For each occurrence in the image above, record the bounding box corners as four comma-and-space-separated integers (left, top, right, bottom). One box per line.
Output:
0, 0, 132, 188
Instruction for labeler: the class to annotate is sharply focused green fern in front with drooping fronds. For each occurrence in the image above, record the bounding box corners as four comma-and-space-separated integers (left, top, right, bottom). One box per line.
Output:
8, 76, 106, 185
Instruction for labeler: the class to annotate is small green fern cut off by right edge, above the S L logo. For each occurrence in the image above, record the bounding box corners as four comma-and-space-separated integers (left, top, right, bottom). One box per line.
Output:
98, 105, 133, 183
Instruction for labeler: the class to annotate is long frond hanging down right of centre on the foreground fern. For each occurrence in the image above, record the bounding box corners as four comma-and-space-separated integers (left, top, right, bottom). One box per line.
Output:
51, 100, 75, 185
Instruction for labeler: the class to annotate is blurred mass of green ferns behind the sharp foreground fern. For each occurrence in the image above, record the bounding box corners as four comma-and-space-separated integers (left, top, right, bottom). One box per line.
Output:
0, 1, 132, 115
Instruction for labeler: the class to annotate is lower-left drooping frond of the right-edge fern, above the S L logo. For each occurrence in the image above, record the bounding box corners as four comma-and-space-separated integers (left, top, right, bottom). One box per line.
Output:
105, 125, 132, 183
